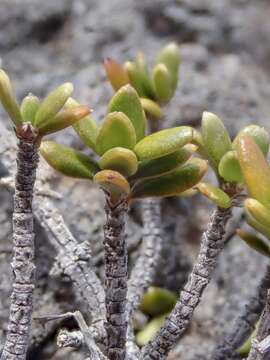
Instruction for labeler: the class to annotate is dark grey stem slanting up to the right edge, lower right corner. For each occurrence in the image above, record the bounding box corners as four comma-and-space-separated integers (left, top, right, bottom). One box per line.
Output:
211, 265, 270, 360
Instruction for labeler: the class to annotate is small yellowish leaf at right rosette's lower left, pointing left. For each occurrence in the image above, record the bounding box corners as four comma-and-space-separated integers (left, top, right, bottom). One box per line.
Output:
196, 182, 232, 209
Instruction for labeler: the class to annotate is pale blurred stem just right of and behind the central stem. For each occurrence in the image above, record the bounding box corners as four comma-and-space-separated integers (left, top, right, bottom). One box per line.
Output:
128, 199, 162, 318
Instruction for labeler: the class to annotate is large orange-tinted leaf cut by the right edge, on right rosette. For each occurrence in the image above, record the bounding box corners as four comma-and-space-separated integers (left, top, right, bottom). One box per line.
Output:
236, 135, 270, 209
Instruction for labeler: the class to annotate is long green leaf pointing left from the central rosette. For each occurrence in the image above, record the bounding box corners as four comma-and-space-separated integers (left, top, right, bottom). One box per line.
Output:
40, 141, 99, 179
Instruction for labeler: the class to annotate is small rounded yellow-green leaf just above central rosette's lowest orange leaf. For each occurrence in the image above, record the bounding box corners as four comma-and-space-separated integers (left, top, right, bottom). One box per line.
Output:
99, 147, 138, 176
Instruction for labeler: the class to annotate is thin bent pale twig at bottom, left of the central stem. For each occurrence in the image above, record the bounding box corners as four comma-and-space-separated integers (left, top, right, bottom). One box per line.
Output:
35, 311, 107, 360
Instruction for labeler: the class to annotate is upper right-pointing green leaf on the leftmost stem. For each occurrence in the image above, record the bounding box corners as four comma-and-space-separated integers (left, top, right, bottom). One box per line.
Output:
35, 83, 73, 128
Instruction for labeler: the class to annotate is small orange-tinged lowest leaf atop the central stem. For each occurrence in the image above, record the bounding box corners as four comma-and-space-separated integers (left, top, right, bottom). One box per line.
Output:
94, 170, 130, 203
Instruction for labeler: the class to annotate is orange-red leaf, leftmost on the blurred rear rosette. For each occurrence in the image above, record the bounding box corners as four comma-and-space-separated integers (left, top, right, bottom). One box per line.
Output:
104, 58, 129, 91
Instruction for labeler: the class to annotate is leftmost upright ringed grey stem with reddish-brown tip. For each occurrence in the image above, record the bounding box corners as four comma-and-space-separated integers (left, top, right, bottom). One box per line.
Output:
1, 123, 39, 360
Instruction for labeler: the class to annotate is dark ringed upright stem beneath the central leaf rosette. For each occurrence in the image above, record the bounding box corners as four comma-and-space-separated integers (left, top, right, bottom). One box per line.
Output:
104, 197, 128, 360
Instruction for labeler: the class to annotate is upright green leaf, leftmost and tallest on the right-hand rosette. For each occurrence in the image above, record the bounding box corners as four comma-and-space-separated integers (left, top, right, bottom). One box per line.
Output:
202, 112, 232, 169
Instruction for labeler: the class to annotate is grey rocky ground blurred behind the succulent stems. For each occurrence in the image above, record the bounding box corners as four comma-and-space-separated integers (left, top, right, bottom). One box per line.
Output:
0, 0, 270, 360
